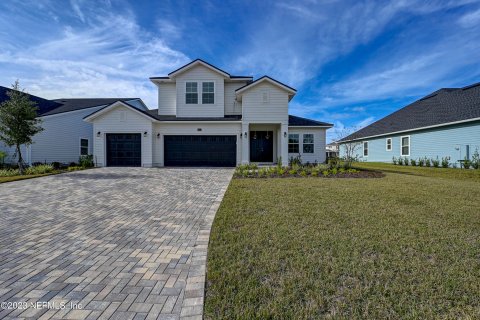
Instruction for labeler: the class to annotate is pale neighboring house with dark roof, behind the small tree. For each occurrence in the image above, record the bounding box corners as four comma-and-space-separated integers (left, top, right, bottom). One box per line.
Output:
0, 86, 148, 164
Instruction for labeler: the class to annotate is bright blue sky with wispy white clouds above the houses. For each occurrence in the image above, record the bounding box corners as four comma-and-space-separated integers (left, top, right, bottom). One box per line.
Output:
0, 0, 480, 139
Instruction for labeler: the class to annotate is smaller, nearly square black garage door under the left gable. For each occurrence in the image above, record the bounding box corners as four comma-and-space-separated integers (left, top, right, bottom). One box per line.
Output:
107, 133, 142, 167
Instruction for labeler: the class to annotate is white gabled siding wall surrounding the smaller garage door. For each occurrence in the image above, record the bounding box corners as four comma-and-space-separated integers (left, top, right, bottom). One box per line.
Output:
93, 106, 155, 167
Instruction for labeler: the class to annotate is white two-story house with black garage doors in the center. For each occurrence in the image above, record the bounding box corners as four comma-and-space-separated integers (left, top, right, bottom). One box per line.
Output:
85, 59, 332, 167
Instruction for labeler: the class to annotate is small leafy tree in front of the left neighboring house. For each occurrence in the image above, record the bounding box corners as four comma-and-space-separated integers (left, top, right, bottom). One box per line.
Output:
0, 80, 43, 174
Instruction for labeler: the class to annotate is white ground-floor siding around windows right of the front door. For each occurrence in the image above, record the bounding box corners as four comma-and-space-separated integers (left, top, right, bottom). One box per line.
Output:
287, 127, 326, 163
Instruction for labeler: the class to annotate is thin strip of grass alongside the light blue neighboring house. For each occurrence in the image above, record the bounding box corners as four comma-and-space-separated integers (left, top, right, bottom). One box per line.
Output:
353, 162, 480, 182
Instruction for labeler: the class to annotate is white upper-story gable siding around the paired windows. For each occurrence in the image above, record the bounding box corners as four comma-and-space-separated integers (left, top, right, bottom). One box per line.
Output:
176, 66, 225, 117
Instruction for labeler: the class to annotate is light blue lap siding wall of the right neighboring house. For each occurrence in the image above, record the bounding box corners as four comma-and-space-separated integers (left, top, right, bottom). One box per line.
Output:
340, 122, 480, 162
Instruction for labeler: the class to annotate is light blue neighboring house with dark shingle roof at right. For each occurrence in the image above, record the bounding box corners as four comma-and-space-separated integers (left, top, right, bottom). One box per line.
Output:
340, 83, 480, 163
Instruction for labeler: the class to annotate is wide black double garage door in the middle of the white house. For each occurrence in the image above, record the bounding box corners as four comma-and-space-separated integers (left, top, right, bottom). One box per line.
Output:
164, 136, 237, 167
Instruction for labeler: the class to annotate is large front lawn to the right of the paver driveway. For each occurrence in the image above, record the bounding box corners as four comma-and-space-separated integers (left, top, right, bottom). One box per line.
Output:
205, 169, 480, 319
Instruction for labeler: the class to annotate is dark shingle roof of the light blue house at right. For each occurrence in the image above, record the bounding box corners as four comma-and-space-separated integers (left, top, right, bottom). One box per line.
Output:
341, 82, 480, 141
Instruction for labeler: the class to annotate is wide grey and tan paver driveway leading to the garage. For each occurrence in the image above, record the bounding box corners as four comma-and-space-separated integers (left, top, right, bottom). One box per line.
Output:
0, 168, 233, 319
